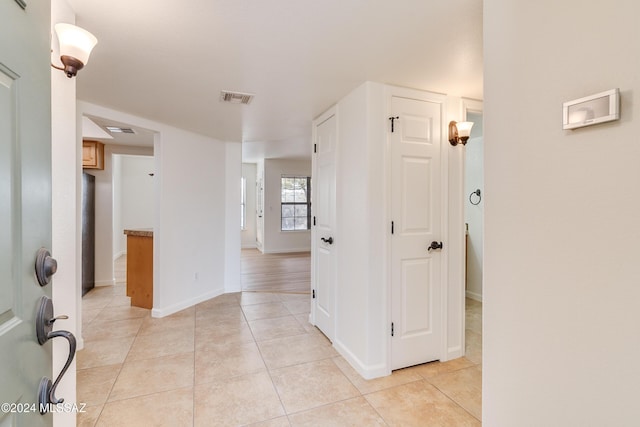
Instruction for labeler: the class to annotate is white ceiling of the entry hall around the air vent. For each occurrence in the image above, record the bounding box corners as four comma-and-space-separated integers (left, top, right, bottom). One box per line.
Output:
69, 0, 482, 160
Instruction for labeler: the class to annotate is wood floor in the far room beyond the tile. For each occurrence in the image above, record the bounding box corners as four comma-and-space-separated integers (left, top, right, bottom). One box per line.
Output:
240, 249, 311, 294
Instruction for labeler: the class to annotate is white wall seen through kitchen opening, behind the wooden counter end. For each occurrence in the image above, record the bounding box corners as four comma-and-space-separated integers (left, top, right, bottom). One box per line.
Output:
113, 155, 155, 259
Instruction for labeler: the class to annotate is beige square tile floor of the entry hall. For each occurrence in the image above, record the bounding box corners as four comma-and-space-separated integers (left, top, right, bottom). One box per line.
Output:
78, 260, 482, 427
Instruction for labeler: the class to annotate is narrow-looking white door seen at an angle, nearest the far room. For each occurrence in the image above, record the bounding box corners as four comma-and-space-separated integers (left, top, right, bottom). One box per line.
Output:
311, 114, 336, 340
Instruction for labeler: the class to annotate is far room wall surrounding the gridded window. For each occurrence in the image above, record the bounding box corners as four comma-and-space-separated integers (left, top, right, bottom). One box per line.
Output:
263, 159, 313, 253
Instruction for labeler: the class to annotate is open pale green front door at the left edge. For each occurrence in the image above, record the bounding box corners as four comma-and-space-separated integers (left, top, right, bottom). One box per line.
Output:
0, 0, 53, 427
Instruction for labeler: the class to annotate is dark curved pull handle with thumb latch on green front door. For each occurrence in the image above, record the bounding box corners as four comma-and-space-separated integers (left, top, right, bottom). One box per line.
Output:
36, 296, 76, 414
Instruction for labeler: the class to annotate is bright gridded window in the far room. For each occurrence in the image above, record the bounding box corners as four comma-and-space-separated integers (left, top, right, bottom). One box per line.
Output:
280, 176, 311, 231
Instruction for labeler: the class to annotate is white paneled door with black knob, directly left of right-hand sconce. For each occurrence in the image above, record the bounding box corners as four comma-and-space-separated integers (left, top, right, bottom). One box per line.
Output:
389, 96, 446, 369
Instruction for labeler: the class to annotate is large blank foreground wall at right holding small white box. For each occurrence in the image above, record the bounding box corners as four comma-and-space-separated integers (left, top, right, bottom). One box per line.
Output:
482, 0, 640, 427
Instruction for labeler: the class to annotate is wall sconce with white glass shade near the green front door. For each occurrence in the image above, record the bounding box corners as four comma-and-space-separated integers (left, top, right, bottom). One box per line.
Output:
51, 24, 98, 78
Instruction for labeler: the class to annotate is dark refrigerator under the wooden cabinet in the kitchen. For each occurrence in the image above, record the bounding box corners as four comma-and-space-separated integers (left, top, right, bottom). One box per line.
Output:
82, 172, 96, 296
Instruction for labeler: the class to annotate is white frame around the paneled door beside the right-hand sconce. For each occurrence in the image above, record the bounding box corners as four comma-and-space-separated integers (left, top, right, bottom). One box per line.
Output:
384, 86, 450, 373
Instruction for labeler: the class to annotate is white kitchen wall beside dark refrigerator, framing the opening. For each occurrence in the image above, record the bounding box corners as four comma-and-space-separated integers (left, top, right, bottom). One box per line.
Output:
90, 145, 153, 286
